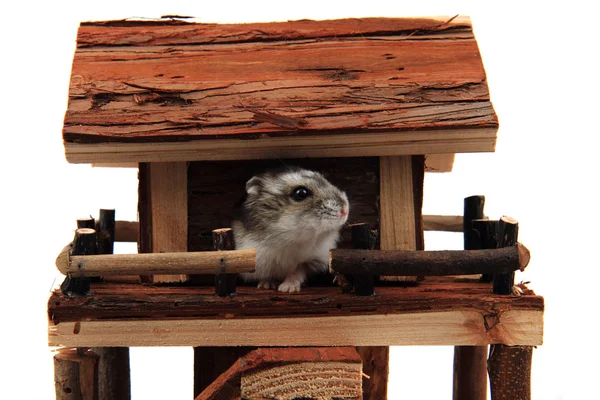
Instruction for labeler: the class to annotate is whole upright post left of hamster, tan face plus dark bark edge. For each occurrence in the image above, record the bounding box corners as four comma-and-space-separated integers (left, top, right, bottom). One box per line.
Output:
139, 162, 188, 283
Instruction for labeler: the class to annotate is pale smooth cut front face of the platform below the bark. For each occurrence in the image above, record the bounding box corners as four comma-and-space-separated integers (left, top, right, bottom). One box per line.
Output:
48, 308, 543, 347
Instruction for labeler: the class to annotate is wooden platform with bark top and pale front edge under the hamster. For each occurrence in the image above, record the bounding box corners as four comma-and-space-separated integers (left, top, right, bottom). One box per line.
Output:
48, 278, 544, 347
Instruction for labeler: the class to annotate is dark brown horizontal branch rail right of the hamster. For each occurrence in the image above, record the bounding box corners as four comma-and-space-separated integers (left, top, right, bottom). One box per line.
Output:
329, 243, 530, 276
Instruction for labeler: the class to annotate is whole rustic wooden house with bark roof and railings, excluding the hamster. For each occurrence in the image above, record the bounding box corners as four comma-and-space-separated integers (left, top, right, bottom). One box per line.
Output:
48, 17, 544, 399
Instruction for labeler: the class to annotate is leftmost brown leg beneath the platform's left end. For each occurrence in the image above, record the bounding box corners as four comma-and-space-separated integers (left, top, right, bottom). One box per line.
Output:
54, 349, 99, 400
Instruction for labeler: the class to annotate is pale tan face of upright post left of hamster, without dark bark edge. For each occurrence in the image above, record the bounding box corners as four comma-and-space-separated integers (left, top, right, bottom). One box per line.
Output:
148, 162, 188, 283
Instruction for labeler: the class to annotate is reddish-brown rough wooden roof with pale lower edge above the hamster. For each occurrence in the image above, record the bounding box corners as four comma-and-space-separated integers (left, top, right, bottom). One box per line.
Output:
63, 18, 498, 163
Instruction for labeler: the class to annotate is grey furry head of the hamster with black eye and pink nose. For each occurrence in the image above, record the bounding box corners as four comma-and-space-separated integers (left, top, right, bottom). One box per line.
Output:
240, 168, 349, 236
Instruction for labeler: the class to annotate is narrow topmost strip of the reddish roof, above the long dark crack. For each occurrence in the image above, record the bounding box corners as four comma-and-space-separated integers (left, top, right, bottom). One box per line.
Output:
77, 16, 473, 47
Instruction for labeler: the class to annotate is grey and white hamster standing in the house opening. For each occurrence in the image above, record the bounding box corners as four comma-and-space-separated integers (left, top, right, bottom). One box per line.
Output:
232, 168, 349, 293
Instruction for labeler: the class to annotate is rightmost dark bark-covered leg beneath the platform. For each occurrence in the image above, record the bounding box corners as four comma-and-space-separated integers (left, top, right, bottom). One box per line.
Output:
488, 344, 533, 400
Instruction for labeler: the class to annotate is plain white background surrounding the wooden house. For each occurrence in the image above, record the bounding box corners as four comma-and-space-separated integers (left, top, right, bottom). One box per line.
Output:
0, 0, 600, 400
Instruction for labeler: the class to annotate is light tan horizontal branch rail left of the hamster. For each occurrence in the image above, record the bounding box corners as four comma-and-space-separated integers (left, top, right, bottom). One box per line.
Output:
56, 246, 256, 277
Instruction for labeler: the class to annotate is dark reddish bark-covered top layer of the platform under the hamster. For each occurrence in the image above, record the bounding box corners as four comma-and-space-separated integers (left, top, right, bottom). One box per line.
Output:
48, 277, 544, 324
